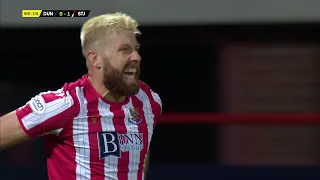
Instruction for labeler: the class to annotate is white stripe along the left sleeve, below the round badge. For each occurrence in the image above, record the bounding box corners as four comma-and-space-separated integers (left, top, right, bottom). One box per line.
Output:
22, 94, 74, 130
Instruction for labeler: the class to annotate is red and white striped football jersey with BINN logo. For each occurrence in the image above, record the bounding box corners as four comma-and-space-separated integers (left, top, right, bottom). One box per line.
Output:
16, 75, 162, 180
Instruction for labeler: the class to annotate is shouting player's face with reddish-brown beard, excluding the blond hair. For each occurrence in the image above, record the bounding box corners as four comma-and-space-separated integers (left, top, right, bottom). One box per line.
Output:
91, 30, 141, 96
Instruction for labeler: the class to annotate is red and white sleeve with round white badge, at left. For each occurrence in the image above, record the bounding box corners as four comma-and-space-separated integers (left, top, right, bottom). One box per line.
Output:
16, 89, 75, 137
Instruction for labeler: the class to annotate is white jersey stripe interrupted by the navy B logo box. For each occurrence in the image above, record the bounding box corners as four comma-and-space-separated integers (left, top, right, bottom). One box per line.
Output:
98, 99, 118, 180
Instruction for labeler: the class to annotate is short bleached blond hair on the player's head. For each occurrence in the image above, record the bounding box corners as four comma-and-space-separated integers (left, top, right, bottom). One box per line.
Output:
80, 12, 141, 55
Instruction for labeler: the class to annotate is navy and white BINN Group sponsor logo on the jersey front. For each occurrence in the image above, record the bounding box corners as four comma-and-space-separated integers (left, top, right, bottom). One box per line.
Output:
98, 132, 143, 159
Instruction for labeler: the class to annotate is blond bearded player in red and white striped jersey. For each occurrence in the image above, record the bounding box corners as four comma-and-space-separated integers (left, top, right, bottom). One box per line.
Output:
0, 13, 162, 180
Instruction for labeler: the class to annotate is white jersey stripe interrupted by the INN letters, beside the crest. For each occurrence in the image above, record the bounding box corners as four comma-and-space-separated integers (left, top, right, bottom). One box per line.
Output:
122, 99, 140, 180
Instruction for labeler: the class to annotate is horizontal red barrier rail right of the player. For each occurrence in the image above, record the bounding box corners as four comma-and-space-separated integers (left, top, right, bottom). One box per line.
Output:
159, 113, 320, 125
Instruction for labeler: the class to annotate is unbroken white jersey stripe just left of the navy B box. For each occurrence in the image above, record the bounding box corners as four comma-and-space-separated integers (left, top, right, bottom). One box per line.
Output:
73, 87, 91, 180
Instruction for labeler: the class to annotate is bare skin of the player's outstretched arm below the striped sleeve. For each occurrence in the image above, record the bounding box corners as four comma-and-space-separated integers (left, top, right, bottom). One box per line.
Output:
0, 111, 30, 150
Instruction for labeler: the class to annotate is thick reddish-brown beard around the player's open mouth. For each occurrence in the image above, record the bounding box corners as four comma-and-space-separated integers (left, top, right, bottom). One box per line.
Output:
103, 62, 140, 96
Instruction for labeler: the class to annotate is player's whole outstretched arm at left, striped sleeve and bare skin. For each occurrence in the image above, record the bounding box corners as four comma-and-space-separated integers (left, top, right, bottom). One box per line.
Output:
0, 90, 74, 149
